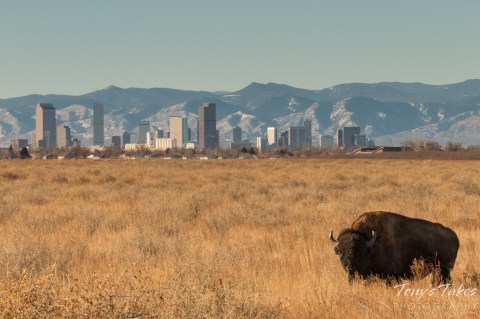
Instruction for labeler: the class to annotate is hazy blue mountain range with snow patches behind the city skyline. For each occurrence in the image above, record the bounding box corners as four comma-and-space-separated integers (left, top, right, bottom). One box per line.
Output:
0, 80, 480, 147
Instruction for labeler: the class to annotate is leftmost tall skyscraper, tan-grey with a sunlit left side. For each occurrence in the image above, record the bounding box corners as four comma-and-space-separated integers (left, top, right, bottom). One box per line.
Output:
35, 103, 57, 148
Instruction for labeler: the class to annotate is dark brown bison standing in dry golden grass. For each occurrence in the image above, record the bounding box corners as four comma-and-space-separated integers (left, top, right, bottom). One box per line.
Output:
329, 212, 459, 284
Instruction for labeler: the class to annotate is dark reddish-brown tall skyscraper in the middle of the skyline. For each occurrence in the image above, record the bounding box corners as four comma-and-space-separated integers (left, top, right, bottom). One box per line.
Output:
198, 103, 218, 149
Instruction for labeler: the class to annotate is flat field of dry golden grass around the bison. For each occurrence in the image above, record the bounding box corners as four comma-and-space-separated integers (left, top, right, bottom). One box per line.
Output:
0, 159, 480, 318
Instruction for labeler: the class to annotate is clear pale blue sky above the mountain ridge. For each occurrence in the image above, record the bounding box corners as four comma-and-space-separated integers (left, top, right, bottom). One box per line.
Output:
0, 0, 480, 98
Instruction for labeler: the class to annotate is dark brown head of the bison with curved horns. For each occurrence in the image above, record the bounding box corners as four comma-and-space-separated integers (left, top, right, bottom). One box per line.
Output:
330, 229, 376, 281
